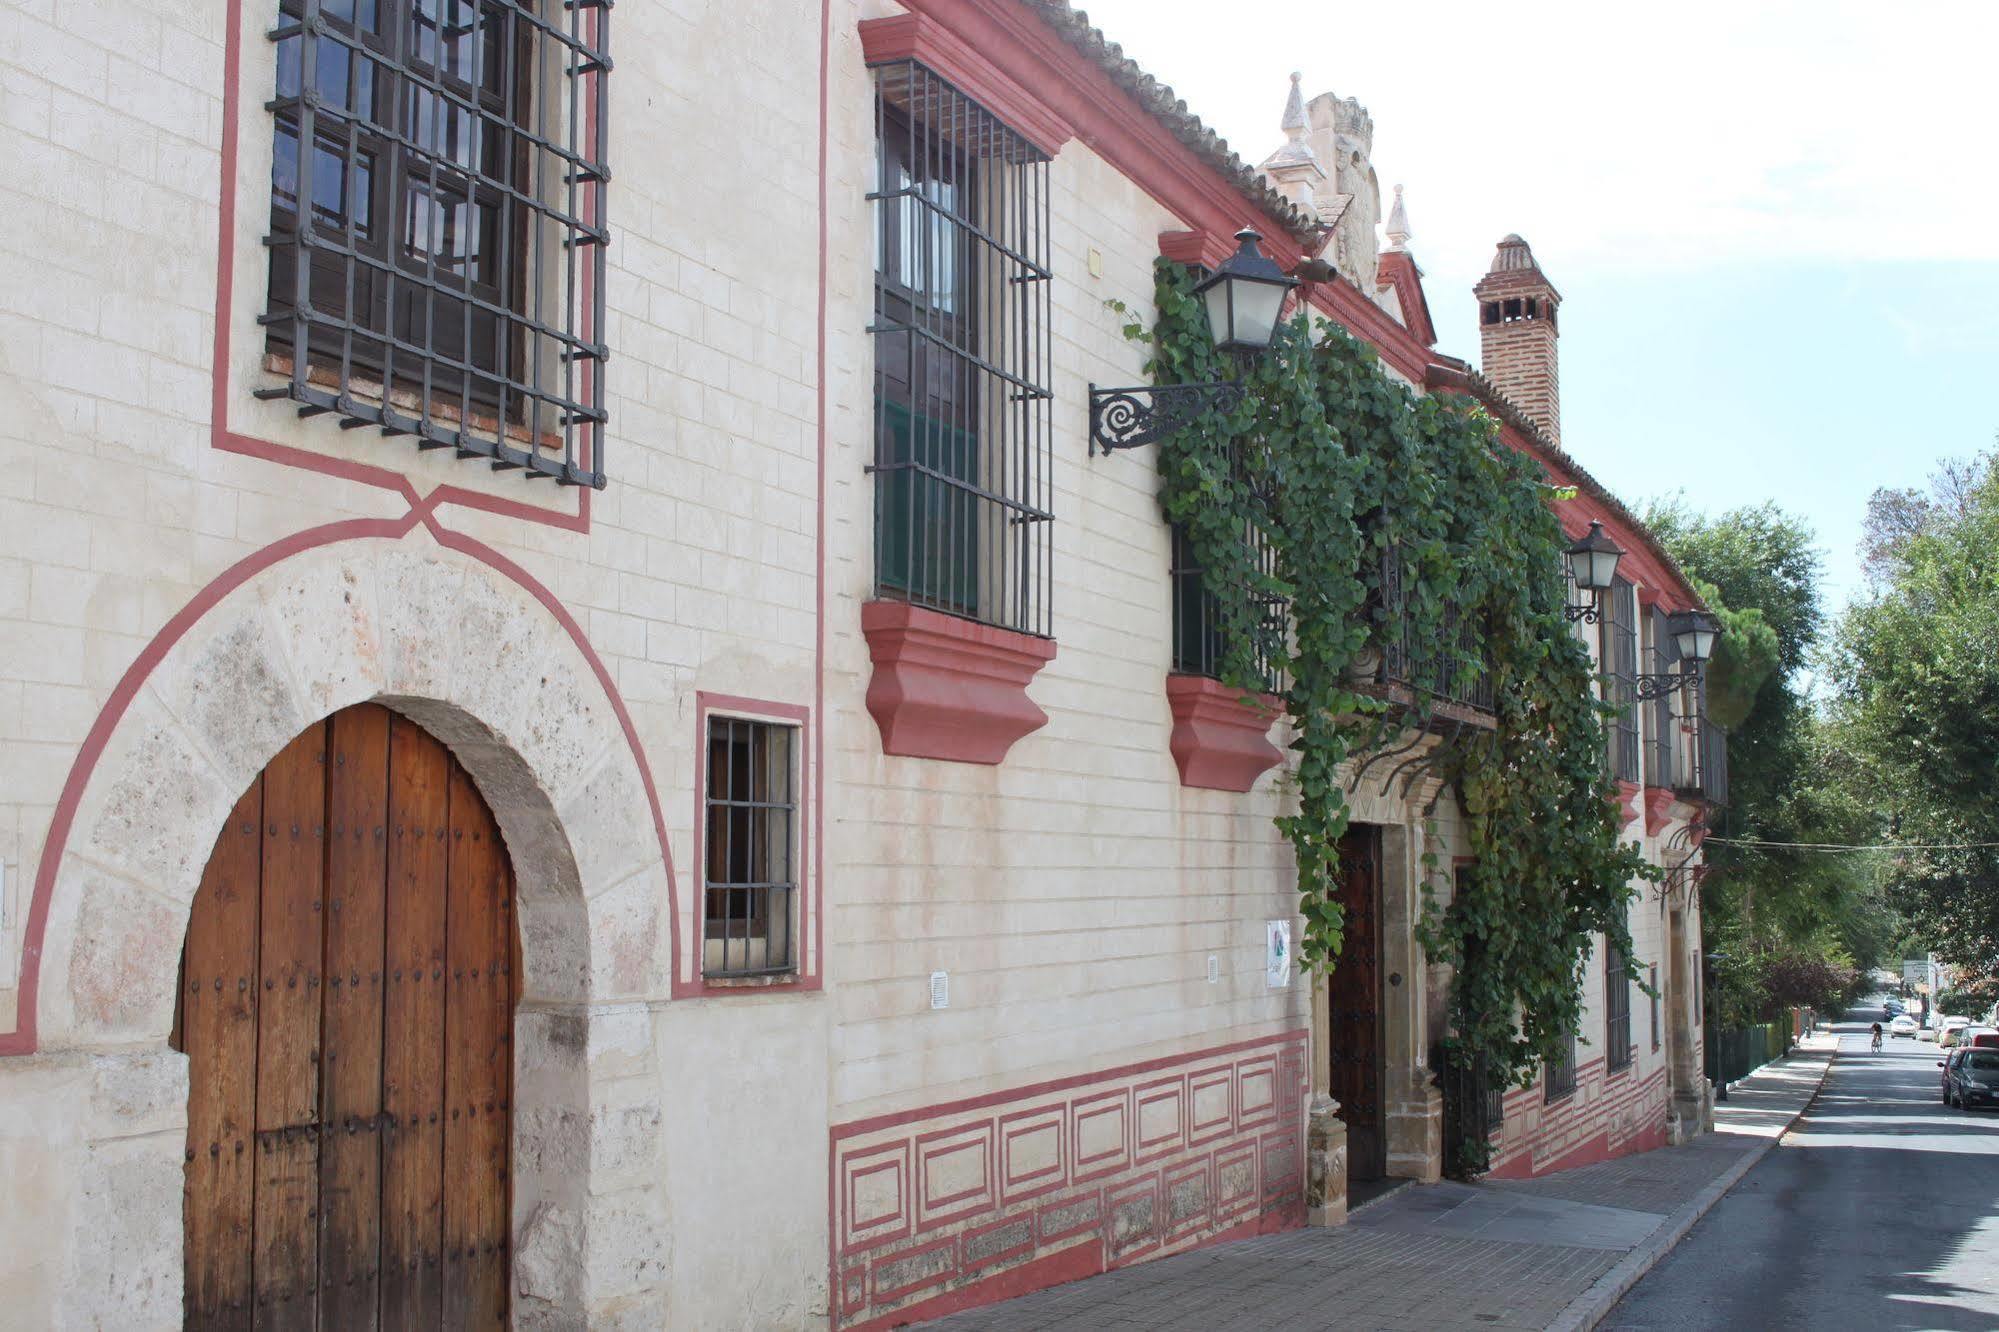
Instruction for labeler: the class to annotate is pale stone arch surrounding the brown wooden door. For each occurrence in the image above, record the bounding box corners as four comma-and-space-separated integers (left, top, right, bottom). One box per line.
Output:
27, 526, 674, 1326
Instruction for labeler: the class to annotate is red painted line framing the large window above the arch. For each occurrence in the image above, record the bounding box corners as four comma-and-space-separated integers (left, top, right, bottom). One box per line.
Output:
208, 0, 594, 532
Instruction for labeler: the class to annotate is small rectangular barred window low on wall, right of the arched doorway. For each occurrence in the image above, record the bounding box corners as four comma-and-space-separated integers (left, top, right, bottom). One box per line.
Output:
702, 716, 798, 980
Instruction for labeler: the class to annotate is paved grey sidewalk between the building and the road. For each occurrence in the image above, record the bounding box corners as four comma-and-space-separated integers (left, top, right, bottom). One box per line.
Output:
924, 1032, 1839, 1332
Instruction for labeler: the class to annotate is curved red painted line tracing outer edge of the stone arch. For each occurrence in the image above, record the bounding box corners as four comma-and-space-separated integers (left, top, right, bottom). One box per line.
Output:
0, 512, 680, 1056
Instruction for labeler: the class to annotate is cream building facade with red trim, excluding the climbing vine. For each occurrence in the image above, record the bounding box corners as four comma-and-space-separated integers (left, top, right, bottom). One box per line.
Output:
0, 0, 1719, 1328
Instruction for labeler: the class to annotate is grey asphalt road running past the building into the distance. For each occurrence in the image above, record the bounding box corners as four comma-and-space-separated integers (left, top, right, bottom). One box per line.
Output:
1597, 1006, 1999, 1332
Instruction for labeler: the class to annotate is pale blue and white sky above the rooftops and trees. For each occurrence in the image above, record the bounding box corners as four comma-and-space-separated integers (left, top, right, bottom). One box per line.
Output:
1073, 0, 1999, 608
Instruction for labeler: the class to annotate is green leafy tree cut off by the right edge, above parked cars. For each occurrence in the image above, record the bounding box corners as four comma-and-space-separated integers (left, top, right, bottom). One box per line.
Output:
1831, 450, 1999, 978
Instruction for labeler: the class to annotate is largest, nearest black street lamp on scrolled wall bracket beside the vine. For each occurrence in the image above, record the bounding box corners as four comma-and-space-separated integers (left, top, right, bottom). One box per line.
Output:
1089, 226, 1297, 456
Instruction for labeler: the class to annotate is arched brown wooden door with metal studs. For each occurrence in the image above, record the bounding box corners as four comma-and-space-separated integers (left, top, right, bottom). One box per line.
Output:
174, 704, 520, 1332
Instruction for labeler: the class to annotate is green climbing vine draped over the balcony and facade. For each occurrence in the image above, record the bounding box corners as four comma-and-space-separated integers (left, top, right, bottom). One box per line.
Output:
1125, 260, 1651, 1170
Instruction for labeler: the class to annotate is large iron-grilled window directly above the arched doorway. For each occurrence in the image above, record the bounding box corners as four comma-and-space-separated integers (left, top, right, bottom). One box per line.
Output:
258, 0, 610, 486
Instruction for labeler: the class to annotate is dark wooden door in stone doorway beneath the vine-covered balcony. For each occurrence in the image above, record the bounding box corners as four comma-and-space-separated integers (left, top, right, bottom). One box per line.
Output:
1327, 824, 1387, 1180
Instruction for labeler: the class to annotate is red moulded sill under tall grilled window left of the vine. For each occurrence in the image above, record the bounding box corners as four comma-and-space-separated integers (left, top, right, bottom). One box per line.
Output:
862, 600, 1055, 764
